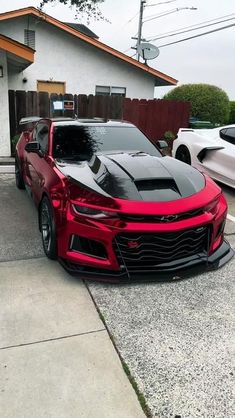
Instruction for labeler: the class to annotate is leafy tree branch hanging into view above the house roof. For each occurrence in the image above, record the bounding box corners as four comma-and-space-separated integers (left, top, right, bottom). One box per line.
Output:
40, 0, 104, 20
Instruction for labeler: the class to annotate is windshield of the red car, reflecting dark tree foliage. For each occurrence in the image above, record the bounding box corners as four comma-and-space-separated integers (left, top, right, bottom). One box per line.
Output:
53, 125, 161, 160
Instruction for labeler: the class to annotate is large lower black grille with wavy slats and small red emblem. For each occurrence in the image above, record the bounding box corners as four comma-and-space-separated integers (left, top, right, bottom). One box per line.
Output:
114, 226, 209, 271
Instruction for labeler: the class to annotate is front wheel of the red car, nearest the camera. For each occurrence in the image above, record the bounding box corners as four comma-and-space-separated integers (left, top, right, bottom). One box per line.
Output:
39, 196, 57, 260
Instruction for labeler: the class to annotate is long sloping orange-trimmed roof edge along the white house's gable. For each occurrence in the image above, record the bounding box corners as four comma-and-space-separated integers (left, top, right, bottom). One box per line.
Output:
0, 7, 177, 86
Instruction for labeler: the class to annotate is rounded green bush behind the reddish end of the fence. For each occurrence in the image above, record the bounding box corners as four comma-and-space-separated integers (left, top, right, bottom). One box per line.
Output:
164, 84, 230, 124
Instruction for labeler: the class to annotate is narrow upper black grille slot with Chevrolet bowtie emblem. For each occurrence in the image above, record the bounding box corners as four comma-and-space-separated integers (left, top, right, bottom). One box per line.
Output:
119, 208, 203, 223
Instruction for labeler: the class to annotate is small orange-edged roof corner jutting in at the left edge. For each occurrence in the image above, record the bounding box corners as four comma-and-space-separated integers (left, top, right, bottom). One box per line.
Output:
0, 34, 35, 70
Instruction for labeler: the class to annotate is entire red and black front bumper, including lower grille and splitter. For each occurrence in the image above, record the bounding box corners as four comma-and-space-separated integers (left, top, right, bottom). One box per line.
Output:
58, 197, 234, 282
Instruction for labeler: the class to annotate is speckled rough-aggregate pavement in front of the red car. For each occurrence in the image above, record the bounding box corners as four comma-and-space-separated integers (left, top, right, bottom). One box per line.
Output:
88, 187, 235, 418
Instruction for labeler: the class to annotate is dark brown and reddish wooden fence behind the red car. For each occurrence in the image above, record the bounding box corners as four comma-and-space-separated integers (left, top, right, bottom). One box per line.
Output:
9, 90, 190, 141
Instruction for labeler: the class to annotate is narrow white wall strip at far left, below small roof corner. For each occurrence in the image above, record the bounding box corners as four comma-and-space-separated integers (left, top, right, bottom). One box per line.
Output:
0, 50, 11, 157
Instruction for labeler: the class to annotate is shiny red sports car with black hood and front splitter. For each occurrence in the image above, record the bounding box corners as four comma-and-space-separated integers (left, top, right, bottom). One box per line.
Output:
15, 118, 233, 281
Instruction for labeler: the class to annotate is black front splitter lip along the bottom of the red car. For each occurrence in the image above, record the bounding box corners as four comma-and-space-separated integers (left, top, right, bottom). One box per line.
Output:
59, 240, 234, 283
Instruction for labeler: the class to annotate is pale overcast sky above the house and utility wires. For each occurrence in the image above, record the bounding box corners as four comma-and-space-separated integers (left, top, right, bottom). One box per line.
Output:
0, 0, 235, 100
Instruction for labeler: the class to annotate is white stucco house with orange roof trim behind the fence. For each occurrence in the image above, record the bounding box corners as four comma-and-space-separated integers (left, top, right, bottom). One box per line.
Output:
0, 7, 177, 155
